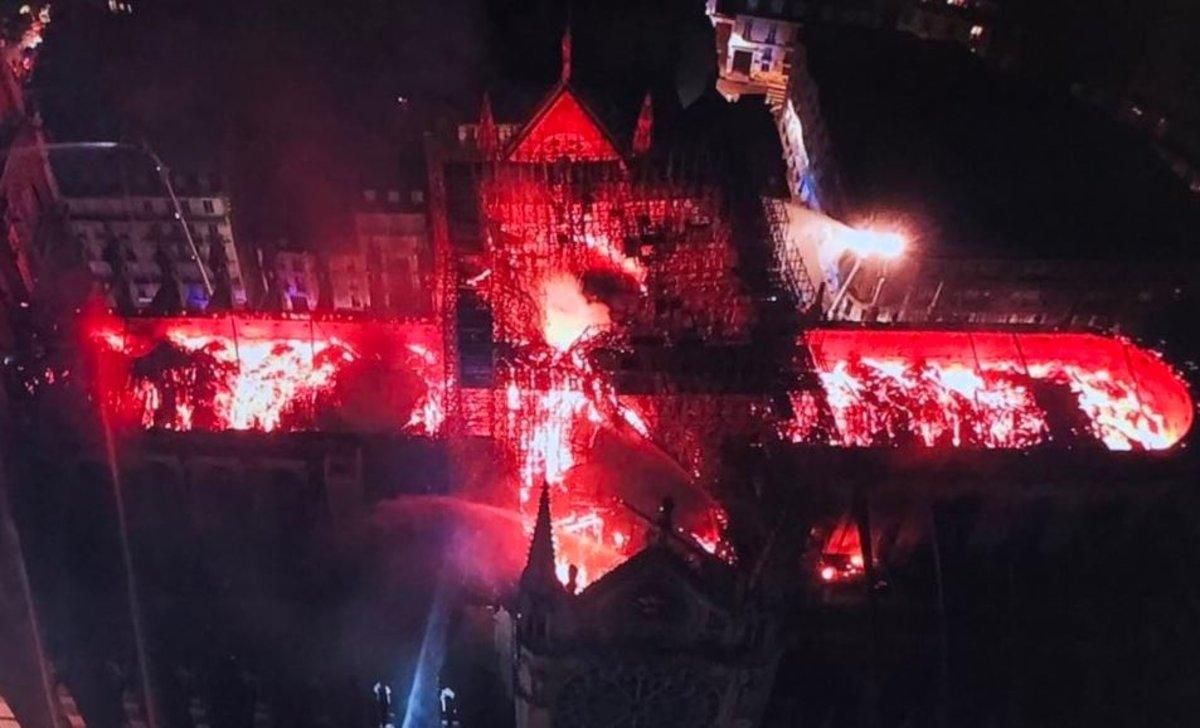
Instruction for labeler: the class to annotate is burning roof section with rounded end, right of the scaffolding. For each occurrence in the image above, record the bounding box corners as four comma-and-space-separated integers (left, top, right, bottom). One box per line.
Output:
785, 330, 1193, 450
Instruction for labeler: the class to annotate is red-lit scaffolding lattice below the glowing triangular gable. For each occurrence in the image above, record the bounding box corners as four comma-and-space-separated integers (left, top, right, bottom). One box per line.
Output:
480, 160, 754, 343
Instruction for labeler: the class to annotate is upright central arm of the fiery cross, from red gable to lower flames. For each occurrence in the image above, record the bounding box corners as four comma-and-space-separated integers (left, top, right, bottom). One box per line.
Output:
464, 85, 752, 586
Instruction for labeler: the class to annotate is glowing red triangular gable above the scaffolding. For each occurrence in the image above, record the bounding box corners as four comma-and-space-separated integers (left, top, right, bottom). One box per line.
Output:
509, 83, 622, 162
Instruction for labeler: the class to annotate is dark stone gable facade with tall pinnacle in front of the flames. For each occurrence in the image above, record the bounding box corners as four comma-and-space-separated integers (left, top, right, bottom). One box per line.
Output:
512, 488, 778, 728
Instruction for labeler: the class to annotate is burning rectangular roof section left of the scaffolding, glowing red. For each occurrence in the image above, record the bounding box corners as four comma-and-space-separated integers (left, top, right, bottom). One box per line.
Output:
89, 315, 445, 434
